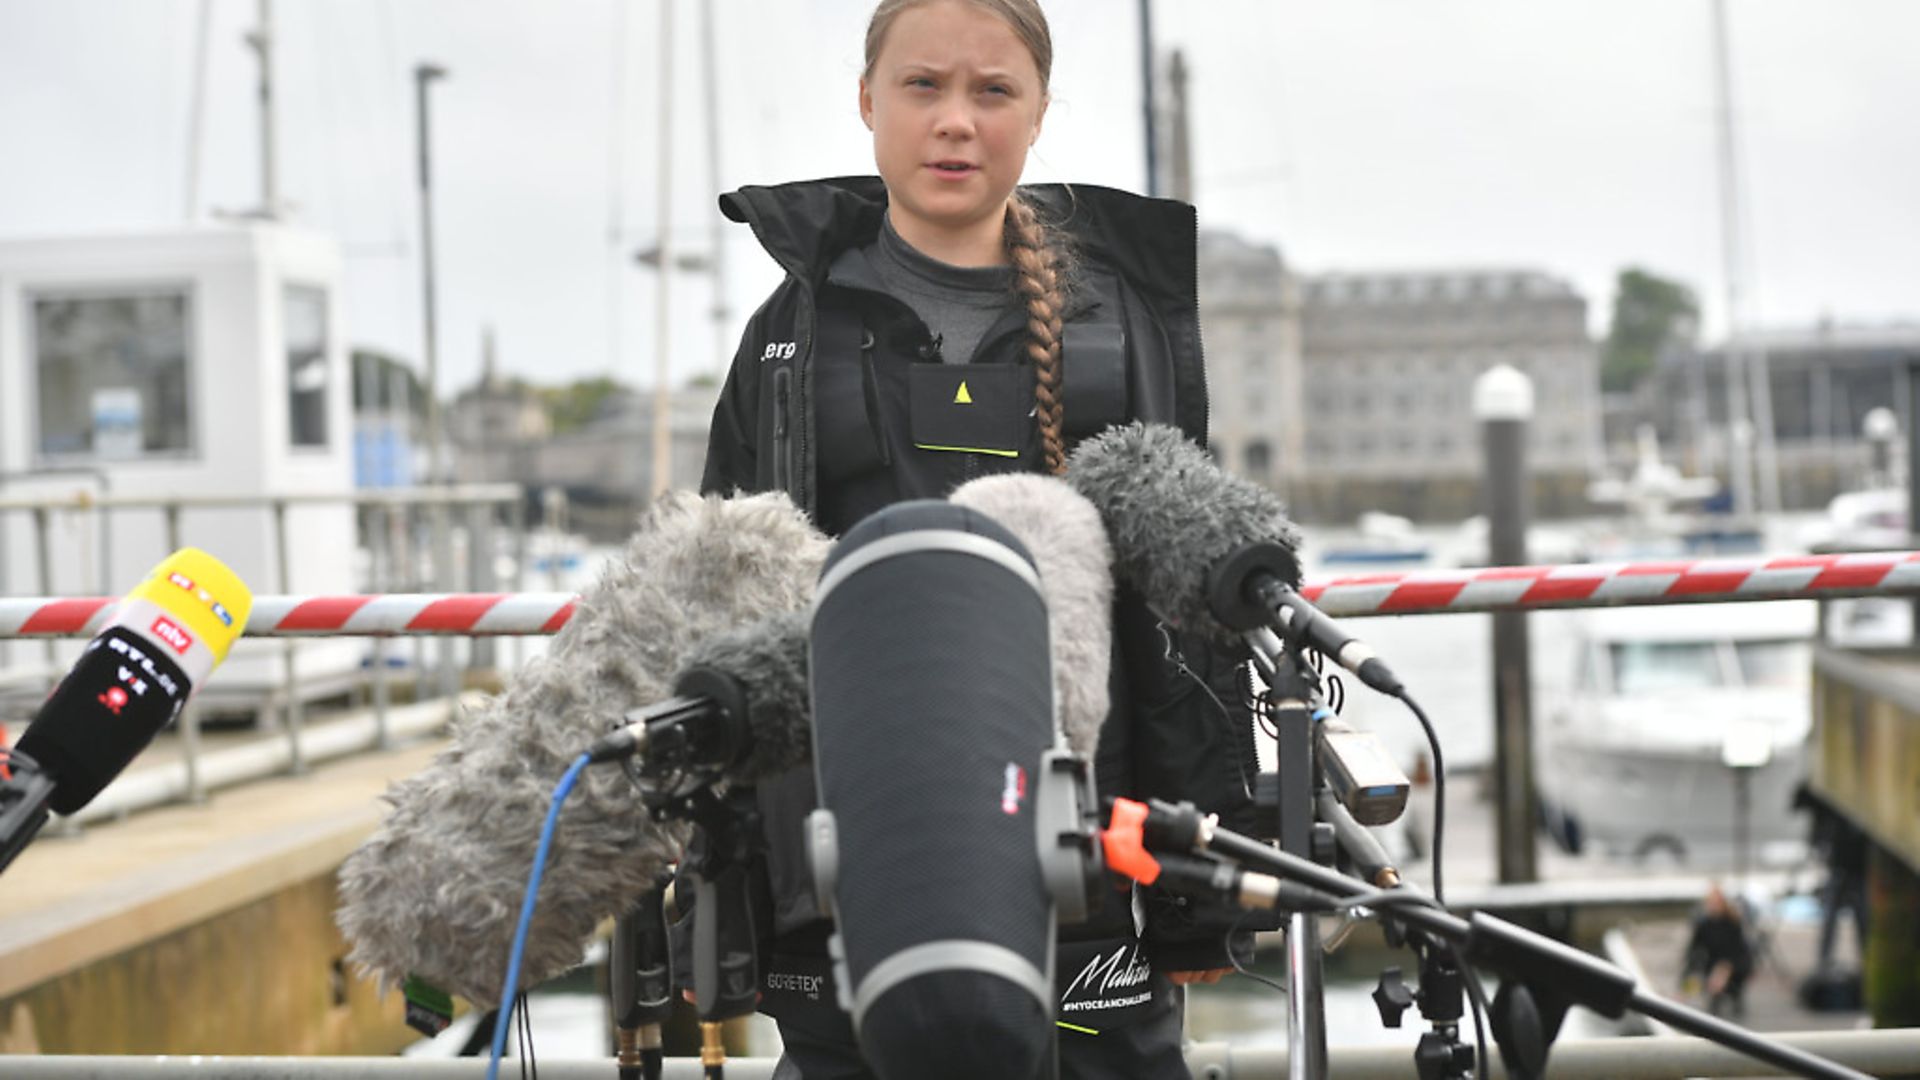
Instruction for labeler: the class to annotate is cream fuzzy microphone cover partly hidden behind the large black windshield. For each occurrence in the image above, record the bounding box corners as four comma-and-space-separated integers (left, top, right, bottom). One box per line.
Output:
947, 473, 1114, 759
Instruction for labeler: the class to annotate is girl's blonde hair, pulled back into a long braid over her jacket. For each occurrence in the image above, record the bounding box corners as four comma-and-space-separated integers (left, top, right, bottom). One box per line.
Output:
860, 0, 1069, 477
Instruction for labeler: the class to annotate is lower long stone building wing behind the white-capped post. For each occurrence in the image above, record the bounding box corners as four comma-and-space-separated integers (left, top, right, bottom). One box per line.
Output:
1290, 269, 1599, 521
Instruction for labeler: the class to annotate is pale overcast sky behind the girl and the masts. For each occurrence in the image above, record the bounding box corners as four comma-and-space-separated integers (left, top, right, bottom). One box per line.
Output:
0, 0, 1920, 395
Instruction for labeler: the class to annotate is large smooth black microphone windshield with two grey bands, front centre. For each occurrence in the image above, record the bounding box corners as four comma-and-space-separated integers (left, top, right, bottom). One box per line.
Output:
808, 500, 1058, 1080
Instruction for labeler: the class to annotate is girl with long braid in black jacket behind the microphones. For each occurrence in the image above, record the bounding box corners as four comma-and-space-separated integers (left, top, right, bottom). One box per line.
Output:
703, 0, 1252, 1080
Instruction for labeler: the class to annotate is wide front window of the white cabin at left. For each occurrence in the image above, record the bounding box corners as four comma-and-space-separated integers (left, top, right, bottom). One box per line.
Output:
33, 288, 192, 461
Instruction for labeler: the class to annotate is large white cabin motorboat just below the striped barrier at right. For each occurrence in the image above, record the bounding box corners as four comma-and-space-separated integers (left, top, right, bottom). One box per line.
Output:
1536, 601, 1816, 869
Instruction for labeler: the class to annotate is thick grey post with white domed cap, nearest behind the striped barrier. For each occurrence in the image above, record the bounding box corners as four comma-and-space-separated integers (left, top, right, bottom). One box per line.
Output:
1473, 365, 1538, 882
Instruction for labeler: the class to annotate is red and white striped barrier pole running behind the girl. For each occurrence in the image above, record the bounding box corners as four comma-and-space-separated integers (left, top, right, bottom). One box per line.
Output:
0, 552, 1920, 638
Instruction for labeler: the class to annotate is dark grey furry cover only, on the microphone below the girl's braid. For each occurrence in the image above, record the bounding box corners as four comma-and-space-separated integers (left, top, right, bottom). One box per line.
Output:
1066, 423, 1300, 642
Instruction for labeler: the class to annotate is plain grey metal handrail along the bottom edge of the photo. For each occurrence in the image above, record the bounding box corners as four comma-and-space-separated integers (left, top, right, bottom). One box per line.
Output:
0, 1028, 1920, 1080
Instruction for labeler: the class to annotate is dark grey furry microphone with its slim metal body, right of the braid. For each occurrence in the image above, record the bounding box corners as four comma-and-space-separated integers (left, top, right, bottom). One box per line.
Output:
1068, 423, 1404, 698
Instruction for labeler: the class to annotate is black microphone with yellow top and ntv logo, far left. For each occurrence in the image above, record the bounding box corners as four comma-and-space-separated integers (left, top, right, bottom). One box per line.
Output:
0, 548, 253, 869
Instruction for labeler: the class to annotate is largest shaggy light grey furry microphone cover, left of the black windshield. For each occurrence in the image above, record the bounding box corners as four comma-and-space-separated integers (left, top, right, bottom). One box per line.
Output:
336, 494, 828, 1001
